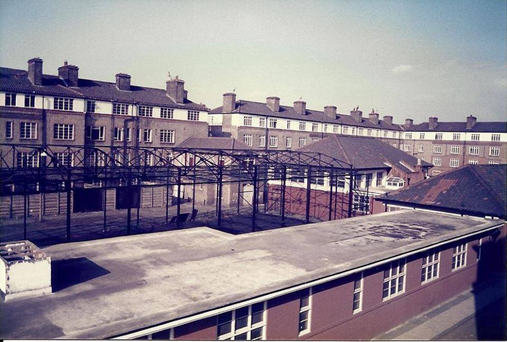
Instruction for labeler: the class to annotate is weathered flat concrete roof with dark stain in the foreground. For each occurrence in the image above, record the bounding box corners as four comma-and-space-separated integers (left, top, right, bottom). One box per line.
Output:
0, 210, 503, 339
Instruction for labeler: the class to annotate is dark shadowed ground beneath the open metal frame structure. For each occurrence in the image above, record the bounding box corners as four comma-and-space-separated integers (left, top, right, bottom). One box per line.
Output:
0, 203, 310, 247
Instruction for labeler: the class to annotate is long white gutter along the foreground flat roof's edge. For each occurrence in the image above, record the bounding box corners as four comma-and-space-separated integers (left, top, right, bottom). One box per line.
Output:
113, 222, 504, 340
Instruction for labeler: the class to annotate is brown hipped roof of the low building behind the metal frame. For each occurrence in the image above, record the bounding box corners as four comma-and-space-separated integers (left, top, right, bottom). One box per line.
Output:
298, 135, 432, 173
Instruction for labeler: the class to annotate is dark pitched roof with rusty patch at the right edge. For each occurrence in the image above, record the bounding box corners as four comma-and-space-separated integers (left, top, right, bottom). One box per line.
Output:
378, 165, 507, 218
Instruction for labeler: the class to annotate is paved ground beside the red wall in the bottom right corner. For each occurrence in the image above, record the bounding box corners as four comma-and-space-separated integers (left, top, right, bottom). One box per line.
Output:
375, 277, 507, 341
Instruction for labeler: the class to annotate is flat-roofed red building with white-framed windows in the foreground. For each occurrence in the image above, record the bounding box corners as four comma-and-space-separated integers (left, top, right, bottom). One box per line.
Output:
0, 210, 505, 340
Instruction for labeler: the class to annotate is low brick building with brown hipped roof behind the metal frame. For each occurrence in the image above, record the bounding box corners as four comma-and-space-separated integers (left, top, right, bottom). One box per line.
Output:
268, 135, 431, 220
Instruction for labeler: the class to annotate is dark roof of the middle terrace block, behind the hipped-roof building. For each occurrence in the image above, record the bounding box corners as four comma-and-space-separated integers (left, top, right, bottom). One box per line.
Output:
210, 100, 402, 131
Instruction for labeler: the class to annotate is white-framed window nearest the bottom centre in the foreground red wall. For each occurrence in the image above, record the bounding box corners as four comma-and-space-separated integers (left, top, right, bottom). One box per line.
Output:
217, 302, 266, 340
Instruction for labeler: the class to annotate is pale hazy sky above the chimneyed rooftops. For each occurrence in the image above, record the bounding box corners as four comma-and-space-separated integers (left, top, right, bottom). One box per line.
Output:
0, 0, 507, 123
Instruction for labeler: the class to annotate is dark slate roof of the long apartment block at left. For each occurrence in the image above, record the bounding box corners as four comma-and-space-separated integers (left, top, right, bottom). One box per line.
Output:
0, 68, 208, 111
